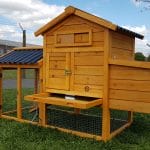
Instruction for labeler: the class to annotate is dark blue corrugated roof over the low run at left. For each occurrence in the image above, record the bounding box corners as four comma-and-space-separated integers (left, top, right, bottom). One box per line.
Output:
0, 49, 43, 64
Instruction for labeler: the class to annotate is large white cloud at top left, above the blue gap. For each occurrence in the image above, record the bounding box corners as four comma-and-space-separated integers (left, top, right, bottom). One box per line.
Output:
0, 0, 64, 27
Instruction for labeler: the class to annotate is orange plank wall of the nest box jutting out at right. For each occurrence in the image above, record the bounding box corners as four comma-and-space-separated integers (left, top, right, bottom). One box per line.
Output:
109, 65, 150, 113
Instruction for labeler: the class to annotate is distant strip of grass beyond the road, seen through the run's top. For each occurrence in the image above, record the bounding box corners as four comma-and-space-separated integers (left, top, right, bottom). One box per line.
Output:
3, 69, 34, 79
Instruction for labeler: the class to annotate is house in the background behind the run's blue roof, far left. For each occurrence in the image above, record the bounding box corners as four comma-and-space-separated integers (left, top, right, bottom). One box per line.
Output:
0, 39, 37, 55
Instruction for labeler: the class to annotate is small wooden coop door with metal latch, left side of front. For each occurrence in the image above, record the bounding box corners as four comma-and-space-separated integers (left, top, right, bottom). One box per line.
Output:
46, 52, 71, 90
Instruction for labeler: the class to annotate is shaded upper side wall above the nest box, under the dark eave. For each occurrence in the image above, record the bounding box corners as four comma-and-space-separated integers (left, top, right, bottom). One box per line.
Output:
110, 31, 135, 60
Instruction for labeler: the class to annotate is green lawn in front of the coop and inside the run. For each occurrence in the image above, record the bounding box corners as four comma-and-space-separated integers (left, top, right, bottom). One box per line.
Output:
0, 89, 150, 150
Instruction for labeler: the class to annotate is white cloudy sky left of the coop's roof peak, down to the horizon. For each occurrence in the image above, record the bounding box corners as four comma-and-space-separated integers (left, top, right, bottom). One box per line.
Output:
0, 0, 65, 44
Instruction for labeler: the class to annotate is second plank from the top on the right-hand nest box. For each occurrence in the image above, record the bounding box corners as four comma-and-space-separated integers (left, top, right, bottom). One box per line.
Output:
110, 79, 150, 92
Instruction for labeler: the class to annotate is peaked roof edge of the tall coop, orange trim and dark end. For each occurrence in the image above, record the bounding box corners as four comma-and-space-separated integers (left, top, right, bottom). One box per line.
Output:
35, 6, 144, 39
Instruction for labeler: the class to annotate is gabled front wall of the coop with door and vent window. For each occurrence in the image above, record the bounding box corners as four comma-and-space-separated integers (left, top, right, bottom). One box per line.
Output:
44, 15, 106, 97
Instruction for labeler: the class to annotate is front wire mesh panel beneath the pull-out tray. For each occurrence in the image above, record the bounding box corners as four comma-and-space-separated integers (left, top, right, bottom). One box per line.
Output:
48, 106, 102, 135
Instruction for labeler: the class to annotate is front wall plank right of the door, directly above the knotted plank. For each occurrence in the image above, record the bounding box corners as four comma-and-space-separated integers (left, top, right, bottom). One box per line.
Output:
74, 75, 104, 85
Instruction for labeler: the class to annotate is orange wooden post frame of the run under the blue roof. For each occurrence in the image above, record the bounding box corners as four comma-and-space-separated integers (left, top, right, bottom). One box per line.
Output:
0, 60, 42, 124
